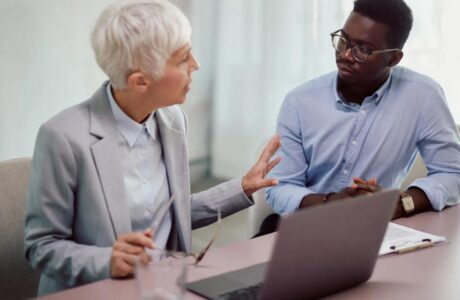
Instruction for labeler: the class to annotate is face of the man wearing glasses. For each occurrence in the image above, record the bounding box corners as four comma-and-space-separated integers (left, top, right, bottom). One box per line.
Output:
335, 12, 392, 85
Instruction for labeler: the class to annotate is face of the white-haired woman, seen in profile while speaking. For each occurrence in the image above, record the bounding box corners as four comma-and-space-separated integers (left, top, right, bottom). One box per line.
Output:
149, 45, 199, 106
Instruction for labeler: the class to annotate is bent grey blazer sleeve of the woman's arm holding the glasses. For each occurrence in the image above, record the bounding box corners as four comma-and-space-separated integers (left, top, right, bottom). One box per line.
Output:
24, 124, 112, 287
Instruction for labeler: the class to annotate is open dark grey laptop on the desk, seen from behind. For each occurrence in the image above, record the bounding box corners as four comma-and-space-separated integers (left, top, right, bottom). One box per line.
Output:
186, 190, 399, 300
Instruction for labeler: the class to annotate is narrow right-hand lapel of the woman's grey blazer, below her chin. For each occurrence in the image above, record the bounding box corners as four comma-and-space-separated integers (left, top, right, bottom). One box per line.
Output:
156, 109, 191, 251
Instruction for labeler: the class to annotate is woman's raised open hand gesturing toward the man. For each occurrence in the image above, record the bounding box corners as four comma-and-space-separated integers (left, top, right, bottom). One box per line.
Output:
241, 135, 281, 197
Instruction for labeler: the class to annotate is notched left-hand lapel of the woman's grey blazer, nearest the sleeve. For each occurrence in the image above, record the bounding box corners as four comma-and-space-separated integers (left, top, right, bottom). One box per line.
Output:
90, 82, 131, 239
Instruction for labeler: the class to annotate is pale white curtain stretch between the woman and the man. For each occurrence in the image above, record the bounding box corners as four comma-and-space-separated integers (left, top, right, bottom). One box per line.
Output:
212, 0, 343, 177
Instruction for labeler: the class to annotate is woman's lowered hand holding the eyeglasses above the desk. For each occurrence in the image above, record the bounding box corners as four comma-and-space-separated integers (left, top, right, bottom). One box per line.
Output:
110, 229, 155, 278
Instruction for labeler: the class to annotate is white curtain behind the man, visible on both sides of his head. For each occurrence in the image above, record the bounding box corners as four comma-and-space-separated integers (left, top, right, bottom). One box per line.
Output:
212, 0, 460, 177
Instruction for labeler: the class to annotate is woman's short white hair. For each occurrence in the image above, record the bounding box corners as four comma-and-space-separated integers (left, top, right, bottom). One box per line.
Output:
91, 0, 192, 89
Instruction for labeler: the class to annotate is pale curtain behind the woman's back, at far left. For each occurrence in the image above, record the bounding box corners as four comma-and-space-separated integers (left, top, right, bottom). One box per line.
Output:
0, 0, 112, 160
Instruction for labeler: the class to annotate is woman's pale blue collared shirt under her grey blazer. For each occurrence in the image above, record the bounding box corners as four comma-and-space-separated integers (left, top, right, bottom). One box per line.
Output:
107, 83, 172, 249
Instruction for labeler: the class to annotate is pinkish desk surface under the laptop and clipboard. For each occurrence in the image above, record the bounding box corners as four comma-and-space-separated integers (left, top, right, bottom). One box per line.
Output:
37, 206, 460, 300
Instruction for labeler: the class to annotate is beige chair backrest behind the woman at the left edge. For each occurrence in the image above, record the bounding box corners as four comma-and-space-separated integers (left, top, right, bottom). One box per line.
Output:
0, 158, 40, 299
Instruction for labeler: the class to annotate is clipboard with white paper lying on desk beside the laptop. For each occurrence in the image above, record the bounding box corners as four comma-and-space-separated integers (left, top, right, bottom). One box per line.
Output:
379, 222, 447, 255
